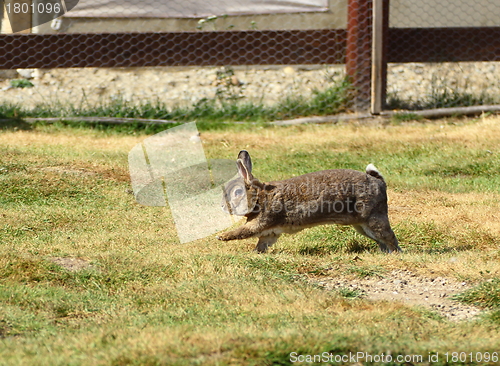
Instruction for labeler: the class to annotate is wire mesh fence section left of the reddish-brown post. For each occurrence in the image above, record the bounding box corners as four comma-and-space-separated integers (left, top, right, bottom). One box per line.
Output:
2, 0, 358, 120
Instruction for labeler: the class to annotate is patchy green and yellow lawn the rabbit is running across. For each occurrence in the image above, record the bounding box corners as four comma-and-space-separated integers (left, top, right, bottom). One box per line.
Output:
0, 116, 500, 366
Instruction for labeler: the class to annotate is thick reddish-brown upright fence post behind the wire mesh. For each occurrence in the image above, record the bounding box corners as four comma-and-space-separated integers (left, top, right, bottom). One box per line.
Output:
346, 0, 372, 111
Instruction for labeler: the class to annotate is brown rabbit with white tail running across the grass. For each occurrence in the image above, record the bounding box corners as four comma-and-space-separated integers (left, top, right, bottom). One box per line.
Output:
217, 150, 402, 253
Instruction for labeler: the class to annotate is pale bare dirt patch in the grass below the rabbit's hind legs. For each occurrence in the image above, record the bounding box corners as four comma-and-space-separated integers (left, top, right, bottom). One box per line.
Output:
318, 270, 481, 321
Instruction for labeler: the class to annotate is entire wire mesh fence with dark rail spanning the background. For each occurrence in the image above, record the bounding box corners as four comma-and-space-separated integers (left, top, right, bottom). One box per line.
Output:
0, 0, 500, 120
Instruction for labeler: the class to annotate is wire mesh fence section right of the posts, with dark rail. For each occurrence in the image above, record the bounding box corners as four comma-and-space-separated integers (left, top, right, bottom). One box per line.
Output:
387, 0, 500, 109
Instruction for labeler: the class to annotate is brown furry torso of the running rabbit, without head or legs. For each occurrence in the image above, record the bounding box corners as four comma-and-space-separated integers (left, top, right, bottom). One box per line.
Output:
256, 169, 387, 232
